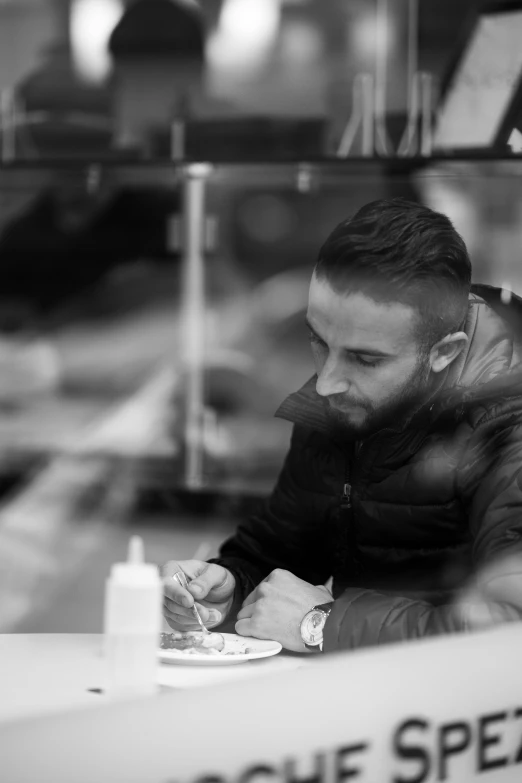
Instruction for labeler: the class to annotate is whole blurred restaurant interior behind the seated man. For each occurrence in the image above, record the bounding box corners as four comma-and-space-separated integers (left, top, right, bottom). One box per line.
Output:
0, 0, 522, 632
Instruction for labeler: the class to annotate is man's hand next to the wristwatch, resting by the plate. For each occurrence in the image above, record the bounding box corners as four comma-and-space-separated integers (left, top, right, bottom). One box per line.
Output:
236, 568, 332, 652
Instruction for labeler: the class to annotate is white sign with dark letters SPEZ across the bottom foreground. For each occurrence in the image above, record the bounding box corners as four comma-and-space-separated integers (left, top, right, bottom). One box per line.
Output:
0, 624, 522, 783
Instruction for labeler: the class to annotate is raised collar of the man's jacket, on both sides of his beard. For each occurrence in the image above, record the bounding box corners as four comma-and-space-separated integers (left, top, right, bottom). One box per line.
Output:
275, 286, 522, 437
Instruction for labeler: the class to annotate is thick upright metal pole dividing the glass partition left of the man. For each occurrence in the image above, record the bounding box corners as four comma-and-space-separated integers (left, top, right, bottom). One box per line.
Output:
182, 163, 211, 489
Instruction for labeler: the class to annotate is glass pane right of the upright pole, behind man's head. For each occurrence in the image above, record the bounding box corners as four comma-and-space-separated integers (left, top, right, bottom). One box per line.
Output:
197, 160, 522, 492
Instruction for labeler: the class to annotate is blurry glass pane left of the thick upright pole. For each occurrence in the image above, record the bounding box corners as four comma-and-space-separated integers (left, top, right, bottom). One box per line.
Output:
0, 165, 181, 500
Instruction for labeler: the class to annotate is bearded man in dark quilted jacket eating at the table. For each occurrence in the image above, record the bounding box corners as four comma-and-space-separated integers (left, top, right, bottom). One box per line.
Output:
160, 200, 522, 652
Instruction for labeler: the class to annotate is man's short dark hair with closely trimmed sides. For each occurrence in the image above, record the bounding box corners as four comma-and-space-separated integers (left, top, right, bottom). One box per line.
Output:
315, 198, 471, 351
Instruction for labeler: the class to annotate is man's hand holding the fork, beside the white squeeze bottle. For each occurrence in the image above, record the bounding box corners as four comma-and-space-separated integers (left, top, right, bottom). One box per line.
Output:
160, 560, 236, 631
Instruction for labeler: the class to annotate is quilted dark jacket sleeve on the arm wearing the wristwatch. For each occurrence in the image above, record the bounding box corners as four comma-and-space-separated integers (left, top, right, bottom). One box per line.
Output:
324, 410, 522, 652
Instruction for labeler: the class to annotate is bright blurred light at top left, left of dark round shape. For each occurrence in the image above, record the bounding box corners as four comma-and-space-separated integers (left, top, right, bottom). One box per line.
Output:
70, 0, 124, 82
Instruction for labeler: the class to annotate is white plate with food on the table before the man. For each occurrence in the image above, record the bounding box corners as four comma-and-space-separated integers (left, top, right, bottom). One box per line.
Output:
158, 633, 283, 666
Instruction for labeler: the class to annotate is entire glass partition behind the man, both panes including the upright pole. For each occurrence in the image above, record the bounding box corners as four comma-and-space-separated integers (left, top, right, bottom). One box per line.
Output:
0, 160, 522, 506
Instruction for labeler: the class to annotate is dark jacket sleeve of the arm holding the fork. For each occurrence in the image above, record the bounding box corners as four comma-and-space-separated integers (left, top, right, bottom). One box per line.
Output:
207, 426, 330, 616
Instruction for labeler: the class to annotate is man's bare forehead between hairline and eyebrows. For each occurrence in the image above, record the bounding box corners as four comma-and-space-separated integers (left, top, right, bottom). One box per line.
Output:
307, 276, 417, 353
